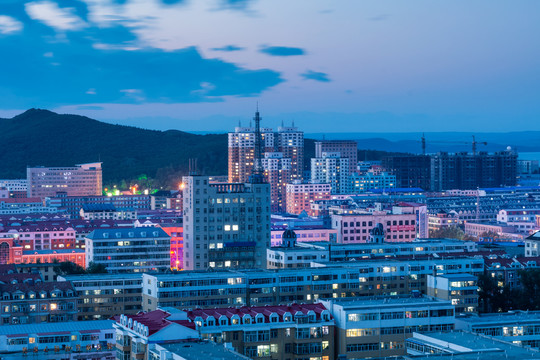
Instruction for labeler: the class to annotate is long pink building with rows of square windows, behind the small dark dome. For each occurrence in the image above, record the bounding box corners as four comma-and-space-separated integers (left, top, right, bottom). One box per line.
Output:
332, 211, 416, 244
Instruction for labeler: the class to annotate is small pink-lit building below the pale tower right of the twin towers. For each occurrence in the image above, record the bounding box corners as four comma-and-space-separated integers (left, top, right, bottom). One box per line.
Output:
285, 181, 332, 216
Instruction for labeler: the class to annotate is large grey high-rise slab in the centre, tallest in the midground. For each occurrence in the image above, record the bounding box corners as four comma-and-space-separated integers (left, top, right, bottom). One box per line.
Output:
183, 175, 270, 270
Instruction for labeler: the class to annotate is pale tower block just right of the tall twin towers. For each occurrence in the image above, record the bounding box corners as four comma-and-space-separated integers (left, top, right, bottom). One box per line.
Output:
311, 152, 352, 194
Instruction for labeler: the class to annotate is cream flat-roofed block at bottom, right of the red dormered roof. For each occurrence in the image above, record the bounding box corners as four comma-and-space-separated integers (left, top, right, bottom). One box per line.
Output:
320, 296, 455, 359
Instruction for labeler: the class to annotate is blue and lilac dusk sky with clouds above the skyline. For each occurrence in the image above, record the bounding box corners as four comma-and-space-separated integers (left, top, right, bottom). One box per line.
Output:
0, 0, 540, 133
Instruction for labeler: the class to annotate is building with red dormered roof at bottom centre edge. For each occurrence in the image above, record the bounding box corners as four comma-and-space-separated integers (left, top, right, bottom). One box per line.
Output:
181, 303, 334, 360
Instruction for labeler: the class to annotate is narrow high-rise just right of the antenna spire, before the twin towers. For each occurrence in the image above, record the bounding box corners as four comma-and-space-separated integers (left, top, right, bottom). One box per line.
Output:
261, 152, 293, 213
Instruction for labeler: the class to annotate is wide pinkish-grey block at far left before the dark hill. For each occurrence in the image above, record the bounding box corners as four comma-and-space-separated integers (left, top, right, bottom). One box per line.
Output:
26, 162, 103, 198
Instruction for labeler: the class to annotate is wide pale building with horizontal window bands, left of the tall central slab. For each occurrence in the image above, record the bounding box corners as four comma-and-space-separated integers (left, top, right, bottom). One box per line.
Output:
85, 227, 171, 273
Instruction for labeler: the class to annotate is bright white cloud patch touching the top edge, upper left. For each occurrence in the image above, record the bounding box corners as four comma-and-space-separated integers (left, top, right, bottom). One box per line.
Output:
25, 1, 86, 31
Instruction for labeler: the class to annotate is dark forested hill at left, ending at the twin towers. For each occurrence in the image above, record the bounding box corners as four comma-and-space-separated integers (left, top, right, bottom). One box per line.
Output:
0, 109, 227, 186
